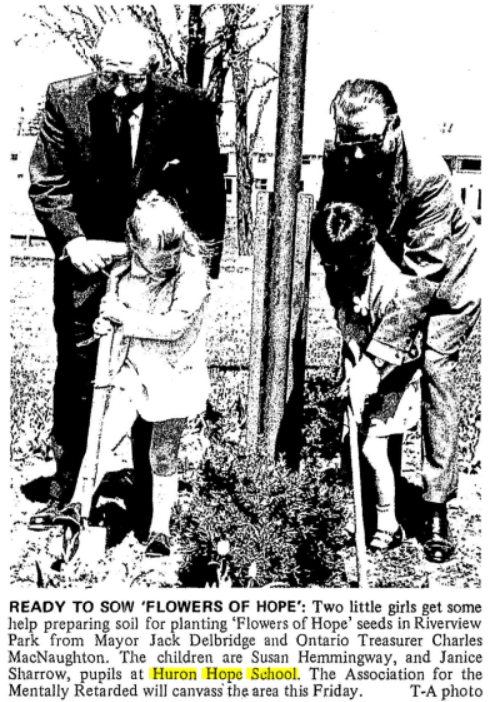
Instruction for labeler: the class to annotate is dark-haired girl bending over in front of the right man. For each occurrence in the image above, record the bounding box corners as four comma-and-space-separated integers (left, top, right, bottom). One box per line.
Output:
314, 203, 421, 551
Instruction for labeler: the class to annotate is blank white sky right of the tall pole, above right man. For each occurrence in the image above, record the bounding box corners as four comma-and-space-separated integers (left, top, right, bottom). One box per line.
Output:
305, 0, 488, 151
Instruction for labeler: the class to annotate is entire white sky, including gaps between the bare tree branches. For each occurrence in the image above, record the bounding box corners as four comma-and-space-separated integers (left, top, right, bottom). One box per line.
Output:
9, 0, 488, 153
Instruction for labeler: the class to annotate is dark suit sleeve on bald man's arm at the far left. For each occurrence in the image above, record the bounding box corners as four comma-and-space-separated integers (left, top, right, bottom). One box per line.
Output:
29, 86, 84, 256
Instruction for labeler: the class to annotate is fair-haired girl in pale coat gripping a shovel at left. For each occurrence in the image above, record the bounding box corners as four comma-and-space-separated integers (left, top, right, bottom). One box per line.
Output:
62, 191, 210, 556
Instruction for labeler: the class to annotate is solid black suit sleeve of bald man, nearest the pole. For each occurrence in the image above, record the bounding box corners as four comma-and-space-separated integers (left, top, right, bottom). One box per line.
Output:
186, 99, 226, 278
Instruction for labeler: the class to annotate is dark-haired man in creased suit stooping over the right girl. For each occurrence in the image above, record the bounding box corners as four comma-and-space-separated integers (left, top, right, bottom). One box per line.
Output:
313, 79, 480, 563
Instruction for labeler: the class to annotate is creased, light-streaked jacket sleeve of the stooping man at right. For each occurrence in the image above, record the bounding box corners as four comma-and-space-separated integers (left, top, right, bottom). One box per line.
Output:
368, 173, 454, 365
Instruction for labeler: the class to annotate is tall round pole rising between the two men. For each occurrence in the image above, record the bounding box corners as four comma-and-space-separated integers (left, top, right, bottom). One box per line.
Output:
265, 5, 308, 460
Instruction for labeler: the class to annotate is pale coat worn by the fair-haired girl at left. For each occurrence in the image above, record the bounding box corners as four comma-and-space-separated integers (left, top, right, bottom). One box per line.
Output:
111, 251, 210, 422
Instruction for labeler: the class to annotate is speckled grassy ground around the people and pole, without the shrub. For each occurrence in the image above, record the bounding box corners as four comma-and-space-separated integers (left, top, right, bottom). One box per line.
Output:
10, 245, 481, 588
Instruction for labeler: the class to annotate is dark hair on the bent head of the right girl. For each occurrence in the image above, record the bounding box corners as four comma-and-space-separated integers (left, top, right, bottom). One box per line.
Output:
314, 202, 376, 274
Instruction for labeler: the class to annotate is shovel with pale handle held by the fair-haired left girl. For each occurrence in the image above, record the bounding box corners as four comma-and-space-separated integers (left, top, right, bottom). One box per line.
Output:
62, 263, 128, 564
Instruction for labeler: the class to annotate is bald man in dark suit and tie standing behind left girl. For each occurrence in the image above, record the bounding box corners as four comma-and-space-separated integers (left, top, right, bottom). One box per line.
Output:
29, 22, 226, 528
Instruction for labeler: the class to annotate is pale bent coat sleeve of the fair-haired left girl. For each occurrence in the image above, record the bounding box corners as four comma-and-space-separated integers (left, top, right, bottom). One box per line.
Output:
122, 262, 209, 341
